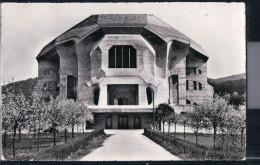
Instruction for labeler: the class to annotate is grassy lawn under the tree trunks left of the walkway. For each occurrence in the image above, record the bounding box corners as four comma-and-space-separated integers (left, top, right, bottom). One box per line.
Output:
2, 132, 98, 160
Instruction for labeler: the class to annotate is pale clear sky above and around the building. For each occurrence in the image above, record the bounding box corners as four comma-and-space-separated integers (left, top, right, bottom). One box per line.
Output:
1, 2, 246, 83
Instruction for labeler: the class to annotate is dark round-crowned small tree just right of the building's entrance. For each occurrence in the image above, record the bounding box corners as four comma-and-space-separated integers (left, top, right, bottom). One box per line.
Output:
155, 103, 174, 133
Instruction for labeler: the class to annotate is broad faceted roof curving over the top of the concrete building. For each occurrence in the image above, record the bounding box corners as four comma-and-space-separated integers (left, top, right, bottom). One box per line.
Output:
37, 14, 207, 58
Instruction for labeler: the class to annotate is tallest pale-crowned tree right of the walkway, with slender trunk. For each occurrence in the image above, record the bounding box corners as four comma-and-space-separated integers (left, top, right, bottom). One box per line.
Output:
203, 94, 228, 148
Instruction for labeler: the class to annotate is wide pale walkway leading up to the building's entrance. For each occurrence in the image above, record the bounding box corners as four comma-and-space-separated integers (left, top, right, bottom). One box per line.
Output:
81, 129, 180, 161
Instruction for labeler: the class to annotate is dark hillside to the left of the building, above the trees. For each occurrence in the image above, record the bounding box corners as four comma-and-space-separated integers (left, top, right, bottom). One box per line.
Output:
2, 78, 38, 99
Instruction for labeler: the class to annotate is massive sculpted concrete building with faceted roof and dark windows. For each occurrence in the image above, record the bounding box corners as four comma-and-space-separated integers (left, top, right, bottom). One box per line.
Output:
36, 15, 213, 129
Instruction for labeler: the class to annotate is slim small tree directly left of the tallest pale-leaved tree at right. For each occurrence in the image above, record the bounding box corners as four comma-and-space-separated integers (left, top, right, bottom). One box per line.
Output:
189, 104, 205, 144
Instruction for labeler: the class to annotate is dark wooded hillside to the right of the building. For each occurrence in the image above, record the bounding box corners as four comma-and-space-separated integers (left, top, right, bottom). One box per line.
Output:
208, 73, 246, 95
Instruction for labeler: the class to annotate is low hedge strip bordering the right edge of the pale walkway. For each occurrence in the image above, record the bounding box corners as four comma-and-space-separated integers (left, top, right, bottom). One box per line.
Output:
144, 128, 243, 160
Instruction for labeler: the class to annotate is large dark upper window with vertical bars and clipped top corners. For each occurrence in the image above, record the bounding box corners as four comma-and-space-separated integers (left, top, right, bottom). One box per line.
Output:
108, 45, 137, 68
